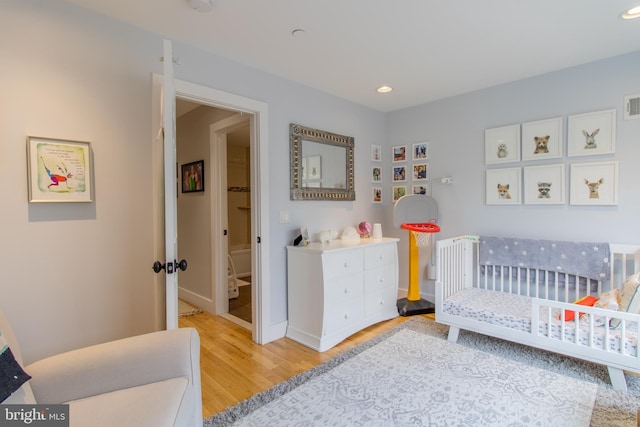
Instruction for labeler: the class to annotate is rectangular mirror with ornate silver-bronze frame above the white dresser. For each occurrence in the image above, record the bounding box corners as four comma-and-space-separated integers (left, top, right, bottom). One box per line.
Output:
289, 123, 356, 201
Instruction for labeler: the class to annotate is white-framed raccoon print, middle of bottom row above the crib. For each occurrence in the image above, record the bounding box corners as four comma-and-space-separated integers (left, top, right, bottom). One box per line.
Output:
524, 164, 566, 205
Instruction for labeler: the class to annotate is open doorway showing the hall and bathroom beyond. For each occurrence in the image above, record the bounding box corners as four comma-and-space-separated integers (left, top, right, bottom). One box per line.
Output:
176, 99, 254, 330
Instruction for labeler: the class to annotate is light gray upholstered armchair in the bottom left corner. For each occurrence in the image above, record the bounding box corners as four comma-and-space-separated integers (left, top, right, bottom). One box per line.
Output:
0, 312, 202, 427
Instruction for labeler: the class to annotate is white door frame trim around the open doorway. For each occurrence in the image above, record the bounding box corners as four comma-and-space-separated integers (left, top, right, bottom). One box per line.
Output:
154, 74, 271, 344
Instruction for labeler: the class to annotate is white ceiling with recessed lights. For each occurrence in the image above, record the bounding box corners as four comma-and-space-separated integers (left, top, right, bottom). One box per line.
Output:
66, 0, 640, 112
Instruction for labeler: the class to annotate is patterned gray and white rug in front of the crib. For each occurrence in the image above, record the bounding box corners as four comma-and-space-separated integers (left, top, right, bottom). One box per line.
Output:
204, 317, 640, 426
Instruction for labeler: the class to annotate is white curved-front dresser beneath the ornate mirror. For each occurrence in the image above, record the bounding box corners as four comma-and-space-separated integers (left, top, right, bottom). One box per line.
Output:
287, 238, 398, 351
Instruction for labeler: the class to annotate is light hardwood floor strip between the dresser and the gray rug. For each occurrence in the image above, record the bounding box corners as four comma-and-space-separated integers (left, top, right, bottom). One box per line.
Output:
179, 313, 420, 417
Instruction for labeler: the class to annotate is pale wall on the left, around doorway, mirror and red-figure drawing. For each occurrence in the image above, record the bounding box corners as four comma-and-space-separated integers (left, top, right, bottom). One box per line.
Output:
0, 0, 388, 363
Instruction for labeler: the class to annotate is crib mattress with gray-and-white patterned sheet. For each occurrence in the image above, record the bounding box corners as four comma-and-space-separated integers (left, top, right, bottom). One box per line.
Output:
442, 288, 638, 356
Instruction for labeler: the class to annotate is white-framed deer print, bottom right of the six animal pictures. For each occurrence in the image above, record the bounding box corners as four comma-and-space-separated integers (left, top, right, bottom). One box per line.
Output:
569, 161, 618, 205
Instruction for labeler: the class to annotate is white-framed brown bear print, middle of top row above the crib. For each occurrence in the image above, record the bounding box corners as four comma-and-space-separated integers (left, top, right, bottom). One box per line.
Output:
521, 117, 563, 161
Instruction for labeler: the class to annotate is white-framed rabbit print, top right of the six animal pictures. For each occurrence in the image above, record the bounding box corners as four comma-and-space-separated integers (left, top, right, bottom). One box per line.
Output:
567, 109, 616, 157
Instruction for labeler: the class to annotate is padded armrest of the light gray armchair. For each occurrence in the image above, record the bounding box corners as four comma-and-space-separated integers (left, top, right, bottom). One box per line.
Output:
25, 328, 201, 404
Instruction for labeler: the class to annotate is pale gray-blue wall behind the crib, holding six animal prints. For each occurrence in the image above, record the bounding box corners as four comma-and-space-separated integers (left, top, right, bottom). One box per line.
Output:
386, 52, 640, 300
